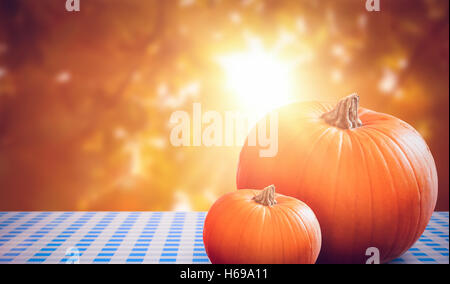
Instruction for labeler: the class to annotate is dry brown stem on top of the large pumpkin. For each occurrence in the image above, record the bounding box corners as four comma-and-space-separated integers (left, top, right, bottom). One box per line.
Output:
321, 94, 362, 129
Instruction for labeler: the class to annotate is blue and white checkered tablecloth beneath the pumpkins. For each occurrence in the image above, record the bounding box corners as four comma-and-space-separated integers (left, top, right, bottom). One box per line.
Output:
0, 212, 449, 264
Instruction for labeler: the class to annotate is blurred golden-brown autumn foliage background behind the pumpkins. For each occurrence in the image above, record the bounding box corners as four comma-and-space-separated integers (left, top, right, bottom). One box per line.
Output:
0, 0, 449, 210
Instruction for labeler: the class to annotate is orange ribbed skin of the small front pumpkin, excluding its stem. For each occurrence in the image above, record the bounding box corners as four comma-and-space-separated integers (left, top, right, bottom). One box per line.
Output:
203, 186, 321, 264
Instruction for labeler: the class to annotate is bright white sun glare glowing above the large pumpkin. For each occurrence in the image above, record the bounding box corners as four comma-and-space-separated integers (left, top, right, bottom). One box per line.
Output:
219, 42, 292, 114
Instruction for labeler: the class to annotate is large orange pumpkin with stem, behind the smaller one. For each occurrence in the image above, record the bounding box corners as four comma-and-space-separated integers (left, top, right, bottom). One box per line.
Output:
237, 95, 437, 263
